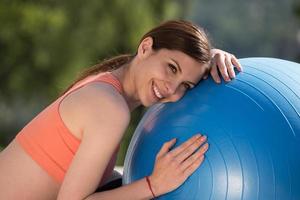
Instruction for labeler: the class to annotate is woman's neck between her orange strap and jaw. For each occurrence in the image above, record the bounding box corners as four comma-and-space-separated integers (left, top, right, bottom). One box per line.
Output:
112, 59, 141, 111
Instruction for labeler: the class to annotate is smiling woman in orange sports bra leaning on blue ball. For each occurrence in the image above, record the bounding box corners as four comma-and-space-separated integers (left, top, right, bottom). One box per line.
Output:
0, 21, 241, 200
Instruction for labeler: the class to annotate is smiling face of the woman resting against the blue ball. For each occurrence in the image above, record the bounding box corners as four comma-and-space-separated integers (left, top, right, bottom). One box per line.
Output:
135, 38, 207, 106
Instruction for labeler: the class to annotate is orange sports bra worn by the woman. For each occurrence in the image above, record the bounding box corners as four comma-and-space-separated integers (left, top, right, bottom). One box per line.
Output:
16, 72, 123, 185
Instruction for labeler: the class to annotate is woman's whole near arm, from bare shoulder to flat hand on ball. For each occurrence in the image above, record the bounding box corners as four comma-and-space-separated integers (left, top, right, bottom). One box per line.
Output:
58, 82, 208, 200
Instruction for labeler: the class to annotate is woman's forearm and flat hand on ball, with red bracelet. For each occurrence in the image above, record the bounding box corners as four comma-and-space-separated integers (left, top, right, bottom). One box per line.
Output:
86, 134, 208, 200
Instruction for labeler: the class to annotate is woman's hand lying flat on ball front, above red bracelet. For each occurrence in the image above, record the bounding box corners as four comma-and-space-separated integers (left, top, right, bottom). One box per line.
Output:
149, 134, 208, 196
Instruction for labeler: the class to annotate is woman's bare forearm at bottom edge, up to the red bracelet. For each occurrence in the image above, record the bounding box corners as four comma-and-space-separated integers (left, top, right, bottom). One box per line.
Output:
85, 178, 153, 200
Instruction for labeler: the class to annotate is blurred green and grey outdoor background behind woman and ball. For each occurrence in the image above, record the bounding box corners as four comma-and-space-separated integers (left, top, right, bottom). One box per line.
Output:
0, 0, 300, 165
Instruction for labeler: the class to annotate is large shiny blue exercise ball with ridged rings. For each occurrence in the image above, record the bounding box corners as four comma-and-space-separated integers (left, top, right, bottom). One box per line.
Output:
123, 58, 300, 200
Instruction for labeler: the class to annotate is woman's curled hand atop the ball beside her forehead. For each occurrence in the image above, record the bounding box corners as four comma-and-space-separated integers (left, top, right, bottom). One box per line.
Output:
204, 49, 242, 83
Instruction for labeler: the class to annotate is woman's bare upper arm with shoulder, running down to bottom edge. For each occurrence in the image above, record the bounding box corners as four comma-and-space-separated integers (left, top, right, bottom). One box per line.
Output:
58, 83, 130, 199
